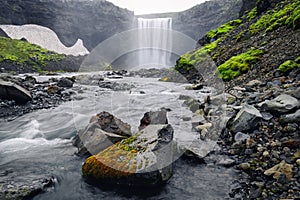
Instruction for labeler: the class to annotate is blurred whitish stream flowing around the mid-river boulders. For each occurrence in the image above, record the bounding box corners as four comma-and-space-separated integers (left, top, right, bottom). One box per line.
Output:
0, 74, 236, 200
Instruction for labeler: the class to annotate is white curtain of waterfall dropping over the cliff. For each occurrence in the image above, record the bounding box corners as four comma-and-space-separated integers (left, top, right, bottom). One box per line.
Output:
138, 18, 172, 68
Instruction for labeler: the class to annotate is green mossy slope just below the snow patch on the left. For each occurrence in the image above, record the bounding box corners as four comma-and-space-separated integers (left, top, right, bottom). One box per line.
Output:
0, 37, 65, 72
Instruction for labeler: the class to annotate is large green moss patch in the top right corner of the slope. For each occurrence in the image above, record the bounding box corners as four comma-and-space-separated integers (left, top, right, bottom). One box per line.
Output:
249, 0, 300, 34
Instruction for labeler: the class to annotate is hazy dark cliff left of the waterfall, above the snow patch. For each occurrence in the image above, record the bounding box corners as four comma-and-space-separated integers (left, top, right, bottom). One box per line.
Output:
0, 0, 134, 50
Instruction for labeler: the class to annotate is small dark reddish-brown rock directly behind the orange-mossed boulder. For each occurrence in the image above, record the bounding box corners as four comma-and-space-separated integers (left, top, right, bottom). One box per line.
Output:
139, 110, 168, 130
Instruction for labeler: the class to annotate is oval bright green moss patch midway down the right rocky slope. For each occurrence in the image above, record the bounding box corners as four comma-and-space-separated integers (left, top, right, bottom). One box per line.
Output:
217, 49, 263, 81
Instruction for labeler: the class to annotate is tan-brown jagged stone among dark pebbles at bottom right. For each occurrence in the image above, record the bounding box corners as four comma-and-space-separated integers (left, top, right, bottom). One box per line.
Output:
264, 160, 293, 179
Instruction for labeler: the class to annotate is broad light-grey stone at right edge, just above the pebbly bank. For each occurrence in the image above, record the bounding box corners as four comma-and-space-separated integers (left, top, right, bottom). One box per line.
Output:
258, 94, 299, 114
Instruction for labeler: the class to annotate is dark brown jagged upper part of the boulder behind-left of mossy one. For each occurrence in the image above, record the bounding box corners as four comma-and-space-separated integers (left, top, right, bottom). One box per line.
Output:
90, 111, 132, 137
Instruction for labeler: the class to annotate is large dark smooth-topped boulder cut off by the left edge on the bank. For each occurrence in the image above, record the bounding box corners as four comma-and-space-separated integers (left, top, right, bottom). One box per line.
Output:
0, 80, 32, 104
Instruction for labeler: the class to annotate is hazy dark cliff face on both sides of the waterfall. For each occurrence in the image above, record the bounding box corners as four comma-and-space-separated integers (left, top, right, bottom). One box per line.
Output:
0, 0, 241, 50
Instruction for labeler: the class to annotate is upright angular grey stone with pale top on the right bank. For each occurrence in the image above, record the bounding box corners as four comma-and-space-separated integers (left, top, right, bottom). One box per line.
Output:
231, 104, 262, 133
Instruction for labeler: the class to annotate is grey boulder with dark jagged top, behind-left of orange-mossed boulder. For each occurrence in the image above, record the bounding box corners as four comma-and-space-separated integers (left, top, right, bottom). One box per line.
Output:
73, 112, 131, 156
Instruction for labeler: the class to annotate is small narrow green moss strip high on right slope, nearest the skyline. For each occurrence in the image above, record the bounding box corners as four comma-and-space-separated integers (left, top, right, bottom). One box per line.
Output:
207, 19, 243, 39
